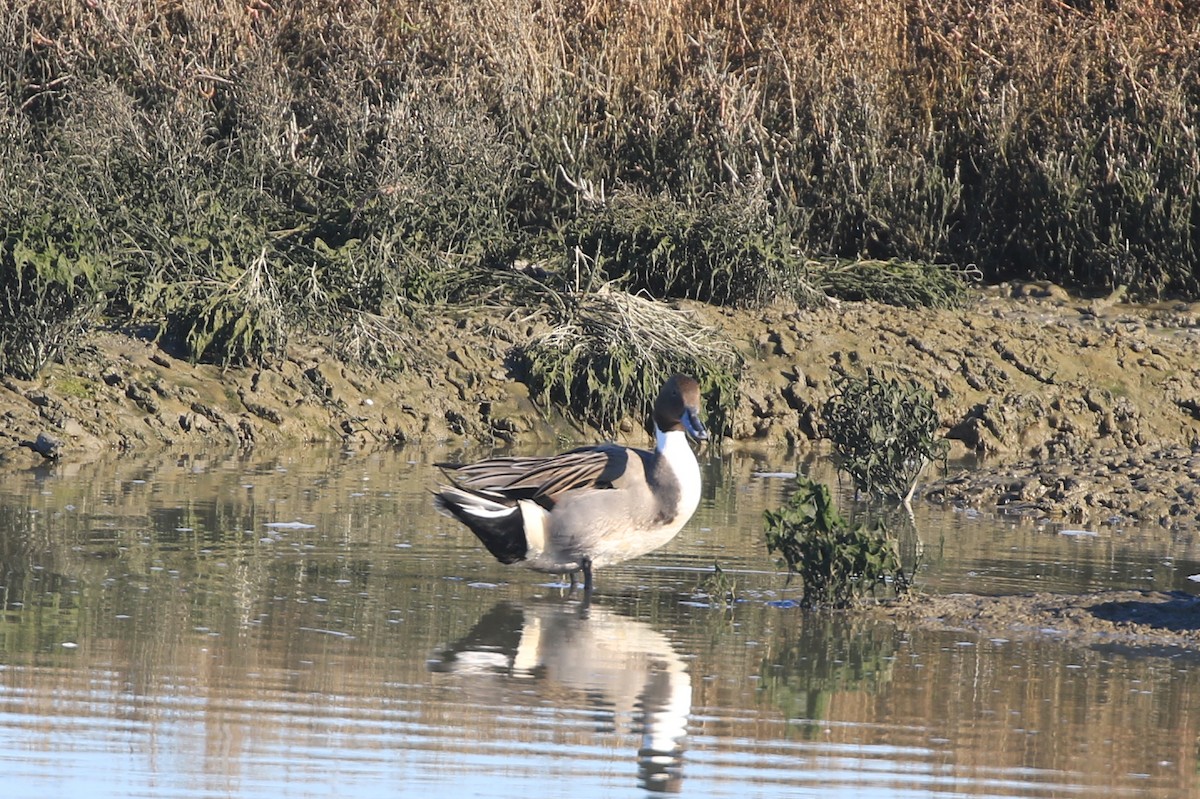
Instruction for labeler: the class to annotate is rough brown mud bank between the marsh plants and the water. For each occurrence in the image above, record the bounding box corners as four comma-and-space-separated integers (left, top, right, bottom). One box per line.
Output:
0, 283, 1200, 529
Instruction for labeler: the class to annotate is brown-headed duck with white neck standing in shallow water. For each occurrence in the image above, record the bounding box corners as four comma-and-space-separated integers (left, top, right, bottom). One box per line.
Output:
433, 374, 708, 596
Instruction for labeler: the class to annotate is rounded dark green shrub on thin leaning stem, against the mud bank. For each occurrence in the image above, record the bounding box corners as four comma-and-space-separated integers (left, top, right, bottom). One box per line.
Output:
822, 370, 947, 501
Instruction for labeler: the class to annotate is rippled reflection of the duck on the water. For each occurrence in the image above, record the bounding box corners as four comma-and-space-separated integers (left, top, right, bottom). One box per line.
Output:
430, 602, 691, 792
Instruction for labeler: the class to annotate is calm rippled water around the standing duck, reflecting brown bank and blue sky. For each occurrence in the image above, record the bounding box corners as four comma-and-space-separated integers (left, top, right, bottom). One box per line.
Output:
0, 450, 1200, 799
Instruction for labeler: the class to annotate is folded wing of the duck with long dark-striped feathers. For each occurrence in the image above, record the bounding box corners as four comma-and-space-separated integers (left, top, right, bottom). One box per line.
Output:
438, 444, 629, 506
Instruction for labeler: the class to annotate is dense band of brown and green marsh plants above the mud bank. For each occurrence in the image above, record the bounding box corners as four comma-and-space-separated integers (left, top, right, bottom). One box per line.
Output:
0, 0, 1200, 423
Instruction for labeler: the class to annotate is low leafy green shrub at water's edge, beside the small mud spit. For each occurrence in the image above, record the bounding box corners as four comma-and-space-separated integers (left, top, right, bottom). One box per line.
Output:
763, 477, 908, 607
